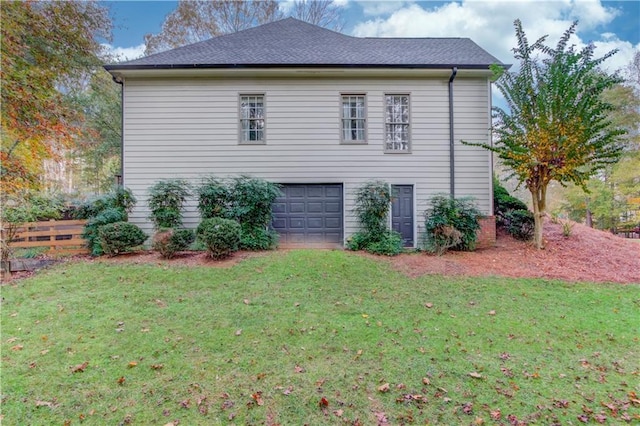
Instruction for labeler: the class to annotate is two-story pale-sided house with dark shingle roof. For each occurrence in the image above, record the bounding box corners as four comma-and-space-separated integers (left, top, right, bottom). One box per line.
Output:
105, 18, 501, 246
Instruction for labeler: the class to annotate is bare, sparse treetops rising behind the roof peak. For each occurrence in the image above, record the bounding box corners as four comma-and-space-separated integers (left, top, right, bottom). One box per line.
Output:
144, 0, 344, 55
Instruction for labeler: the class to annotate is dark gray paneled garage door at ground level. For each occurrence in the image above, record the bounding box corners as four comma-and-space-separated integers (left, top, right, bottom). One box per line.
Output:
273, 184, 343, 247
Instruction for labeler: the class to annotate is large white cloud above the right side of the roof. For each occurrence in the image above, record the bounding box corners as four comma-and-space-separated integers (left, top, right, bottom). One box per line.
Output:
353, 0, 637, 67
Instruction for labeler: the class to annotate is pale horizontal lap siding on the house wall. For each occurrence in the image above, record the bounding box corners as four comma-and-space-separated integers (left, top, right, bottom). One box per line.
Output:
124, 77, 491, 245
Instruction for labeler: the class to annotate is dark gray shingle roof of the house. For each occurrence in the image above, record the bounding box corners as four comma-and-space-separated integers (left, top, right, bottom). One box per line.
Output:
105, 18, 501, 70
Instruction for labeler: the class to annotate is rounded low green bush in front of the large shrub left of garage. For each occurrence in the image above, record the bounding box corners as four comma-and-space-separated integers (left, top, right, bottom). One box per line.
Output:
196, 217, 242, 259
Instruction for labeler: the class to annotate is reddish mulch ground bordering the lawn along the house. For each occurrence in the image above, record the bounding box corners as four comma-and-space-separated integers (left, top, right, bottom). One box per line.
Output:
5, 220, 640, 284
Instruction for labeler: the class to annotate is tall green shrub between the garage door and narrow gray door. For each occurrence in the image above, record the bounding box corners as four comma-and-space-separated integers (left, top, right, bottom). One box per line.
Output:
347, 181, 403, 256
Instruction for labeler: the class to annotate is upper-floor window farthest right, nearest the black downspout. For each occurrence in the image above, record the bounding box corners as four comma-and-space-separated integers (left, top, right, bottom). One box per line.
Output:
384, 95, 410, 152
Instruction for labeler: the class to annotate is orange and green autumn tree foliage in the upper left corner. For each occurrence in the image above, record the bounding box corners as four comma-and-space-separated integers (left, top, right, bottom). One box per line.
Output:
0, 1, 111, 194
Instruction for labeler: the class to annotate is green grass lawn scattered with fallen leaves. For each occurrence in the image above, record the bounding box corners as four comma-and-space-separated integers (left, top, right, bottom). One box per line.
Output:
1, 250, 640, 425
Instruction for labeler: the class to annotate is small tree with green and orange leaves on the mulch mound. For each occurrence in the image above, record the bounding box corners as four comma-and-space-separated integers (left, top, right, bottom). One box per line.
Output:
464, 20, 625, 248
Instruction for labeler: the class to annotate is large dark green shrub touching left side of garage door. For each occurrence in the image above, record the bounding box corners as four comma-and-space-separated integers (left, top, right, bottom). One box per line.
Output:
197, 176, 280, 250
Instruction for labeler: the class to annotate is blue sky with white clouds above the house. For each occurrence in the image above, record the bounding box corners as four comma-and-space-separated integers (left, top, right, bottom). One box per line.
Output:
104, 0, 640, 69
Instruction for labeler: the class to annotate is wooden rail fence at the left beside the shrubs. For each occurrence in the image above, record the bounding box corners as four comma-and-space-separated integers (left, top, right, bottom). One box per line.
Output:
2, 220, 89, 255
